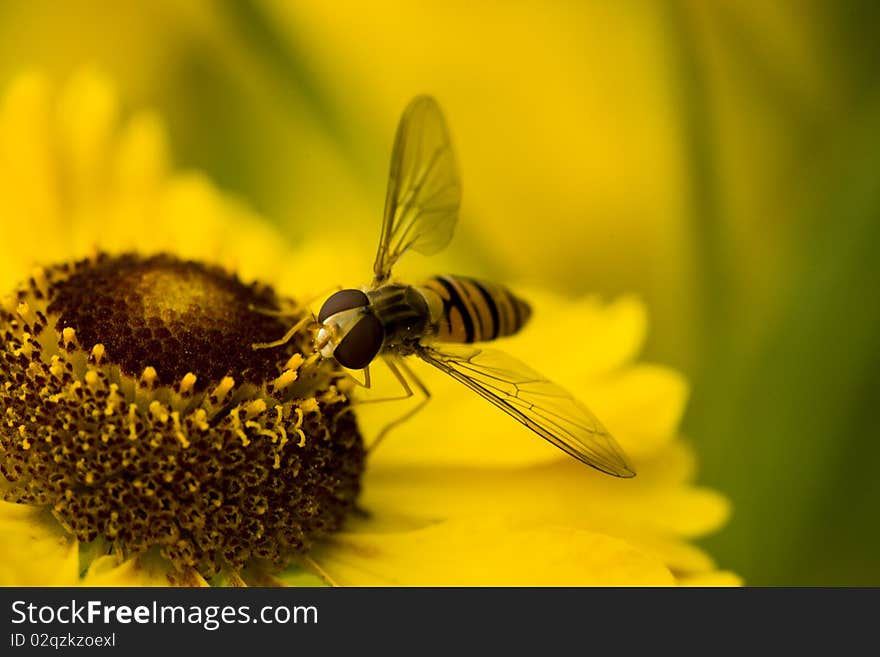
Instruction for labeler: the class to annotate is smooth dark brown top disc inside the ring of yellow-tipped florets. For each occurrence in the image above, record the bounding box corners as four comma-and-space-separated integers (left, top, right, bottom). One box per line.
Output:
48, 255, 285, 389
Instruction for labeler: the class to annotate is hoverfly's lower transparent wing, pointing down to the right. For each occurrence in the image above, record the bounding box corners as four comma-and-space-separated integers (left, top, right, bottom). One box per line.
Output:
418, 345, 635, 477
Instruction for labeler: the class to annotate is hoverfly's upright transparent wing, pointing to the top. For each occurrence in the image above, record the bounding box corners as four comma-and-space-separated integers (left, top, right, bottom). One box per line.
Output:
373, 96, 461, 286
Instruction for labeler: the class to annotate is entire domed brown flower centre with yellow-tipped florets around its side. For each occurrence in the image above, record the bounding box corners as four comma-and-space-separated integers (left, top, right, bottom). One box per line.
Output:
0, 255, 364, 577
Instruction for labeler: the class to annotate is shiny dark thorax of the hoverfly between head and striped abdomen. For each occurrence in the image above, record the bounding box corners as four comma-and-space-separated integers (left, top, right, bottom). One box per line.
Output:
367, 283, 431, 355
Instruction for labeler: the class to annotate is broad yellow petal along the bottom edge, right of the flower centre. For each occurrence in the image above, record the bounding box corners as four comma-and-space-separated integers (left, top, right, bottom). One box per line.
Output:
312, 518, 674, 586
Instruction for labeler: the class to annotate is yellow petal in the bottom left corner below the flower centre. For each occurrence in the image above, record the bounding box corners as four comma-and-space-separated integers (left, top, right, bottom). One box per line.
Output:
0, 502, 79, 586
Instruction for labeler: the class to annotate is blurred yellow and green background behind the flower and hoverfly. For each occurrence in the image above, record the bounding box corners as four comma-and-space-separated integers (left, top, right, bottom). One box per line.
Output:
0, 0, 880, 586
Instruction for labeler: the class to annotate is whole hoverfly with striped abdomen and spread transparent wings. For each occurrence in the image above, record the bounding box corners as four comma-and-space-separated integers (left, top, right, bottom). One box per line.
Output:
254, 96, 635, 477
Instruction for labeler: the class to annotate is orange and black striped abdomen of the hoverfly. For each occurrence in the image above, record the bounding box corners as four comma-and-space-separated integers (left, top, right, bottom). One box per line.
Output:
419, 276, 532, 342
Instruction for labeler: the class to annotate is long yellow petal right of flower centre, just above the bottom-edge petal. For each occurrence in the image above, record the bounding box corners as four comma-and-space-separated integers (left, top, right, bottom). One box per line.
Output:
361, 446, 729, 536
